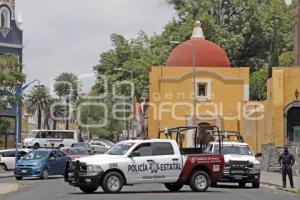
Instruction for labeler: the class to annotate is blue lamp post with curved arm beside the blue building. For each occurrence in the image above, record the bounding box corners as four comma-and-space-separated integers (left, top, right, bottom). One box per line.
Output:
15, 79, 41, 168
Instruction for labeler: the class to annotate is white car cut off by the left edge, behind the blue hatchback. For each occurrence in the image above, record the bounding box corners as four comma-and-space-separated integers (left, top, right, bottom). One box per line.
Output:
0, 149, 30, 171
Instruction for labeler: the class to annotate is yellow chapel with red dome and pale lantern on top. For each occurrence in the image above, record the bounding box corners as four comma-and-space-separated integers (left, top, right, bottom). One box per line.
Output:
149, 22, 249, 147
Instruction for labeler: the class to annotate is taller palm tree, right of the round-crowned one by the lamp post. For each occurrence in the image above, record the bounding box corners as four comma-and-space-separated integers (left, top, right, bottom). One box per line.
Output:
54, 72, 78, 130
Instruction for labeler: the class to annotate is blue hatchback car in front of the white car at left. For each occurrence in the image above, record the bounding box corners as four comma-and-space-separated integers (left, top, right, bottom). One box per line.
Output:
15, 149, 70, 180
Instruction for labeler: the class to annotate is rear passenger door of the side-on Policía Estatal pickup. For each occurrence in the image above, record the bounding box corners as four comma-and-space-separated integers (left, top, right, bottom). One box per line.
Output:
152, 142, 183, 183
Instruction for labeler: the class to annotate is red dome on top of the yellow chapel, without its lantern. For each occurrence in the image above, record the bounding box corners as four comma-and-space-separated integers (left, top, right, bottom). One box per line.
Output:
166, 38, 230, 67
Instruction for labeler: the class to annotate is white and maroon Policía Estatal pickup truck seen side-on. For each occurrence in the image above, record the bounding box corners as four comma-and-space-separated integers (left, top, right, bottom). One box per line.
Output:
65, 139, 224, 193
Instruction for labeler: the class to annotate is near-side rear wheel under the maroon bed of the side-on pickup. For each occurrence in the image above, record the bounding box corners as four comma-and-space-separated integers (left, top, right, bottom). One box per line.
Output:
190, 171, 210, 192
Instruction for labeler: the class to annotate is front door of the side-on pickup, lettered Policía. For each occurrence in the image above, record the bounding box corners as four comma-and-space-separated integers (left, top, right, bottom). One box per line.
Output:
125, 143, 153, 184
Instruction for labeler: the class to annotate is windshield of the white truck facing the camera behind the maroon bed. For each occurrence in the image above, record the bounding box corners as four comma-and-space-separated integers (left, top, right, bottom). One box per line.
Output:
214, 145, 253, 156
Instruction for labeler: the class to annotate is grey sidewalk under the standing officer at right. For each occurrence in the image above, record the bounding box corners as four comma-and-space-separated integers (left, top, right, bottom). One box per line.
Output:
260, 171, 300, 192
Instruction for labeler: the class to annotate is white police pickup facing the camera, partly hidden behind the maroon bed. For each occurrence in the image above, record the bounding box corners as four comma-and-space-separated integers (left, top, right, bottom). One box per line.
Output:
205, 141, 261, 188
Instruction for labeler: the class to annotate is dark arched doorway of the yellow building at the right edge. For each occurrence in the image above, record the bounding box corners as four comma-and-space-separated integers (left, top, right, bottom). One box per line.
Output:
284, 101, 300, 142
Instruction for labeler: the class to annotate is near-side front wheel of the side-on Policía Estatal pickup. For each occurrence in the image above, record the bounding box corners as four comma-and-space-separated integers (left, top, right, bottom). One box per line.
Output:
102, 172, 124, 193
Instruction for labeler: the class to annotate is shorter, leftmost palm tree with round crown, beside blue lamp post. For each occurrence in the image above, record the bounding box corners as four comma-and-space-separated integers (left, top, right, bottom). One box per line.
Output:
26, 86, 51, 129
